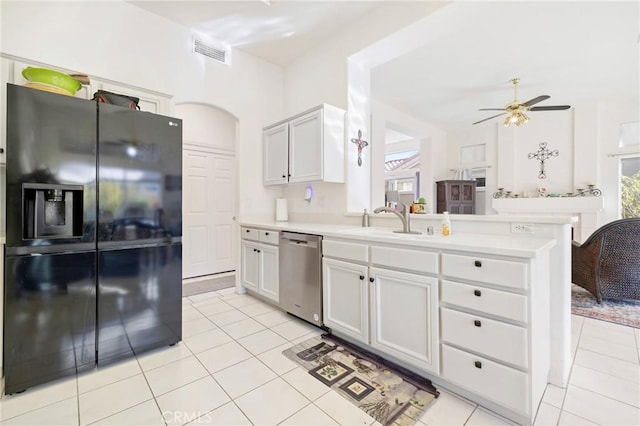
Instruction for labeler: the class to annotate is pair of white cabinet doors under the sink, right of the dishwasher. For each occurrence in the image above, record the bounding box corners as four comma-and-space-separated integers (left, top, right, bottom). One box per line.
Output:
323, 250, 439, 372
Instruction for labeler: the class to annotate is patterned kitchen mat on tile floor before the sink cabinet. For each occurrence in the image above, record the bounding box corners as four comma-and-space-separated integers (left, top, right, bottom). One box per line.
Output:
282, 334, 439, 426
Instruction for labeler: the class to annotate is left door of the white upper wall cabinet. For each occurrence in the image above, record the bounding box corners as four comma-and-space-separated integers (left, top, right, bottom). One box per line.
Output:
263, 123, 289, 185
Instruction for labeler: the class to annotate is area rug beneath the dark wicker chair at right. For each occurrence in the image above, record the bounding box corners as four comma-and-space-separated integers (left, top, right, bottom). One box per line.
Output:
571, 284, 640, 328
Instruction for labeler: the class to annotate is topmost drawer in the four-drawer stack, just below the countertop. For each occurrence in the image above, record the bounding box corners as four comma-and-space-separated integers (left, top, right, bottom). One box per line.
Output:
442, 253, 527, 289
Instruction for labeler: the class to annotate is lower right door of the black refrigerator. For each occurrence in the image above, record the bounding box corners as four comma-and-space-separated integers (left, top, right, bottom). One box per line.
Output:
98, 244, 182, 365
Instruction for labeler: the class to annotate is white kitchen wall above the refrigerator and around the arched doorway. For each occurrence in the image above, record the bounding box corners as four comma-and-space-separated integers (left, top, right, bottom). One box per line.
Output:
0, 1, 283, 217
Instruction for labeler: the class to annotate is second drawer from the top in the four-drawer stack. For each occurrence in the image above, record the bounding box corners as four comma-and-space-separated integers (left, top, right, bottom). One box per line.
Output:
440, 280, 528, 323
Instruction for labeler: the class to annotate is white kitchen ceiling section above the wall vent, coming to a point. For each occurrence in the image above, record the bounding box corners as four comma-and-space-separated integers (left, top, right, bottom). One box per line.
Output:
129, 0, 380, 66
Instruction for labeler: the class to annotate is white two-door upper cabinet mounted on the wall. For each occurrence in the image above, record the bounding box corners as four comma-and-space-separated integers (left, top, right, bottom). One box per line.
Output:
264, 104, 345, 185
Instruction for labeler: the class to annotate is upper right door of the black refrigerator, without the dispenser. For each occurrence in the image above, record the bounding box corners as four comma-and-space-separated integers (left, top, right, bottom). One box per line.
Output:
98, 104, 182, 248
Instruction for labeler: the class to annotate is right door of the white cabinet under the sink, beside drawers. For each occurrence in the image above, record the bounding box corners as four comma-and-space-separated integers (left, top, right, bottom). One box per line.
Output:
369, 268, 438, 373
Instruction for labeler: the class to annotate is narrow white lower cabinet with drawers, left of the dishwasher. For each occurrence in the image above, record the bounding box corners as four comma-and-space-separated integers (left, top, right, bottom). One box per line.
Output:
240, 228, 280, 303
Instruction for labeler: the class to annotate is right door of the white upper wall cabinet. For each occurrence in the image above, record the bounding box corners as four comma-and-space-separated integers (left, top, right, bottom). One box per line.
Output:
289, 110, 324, 183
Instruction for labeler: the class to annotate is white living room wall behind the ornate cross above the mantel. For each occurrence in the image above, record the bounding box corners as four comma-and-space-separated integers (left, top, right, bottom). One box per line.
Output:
448, 101, 640, 228
